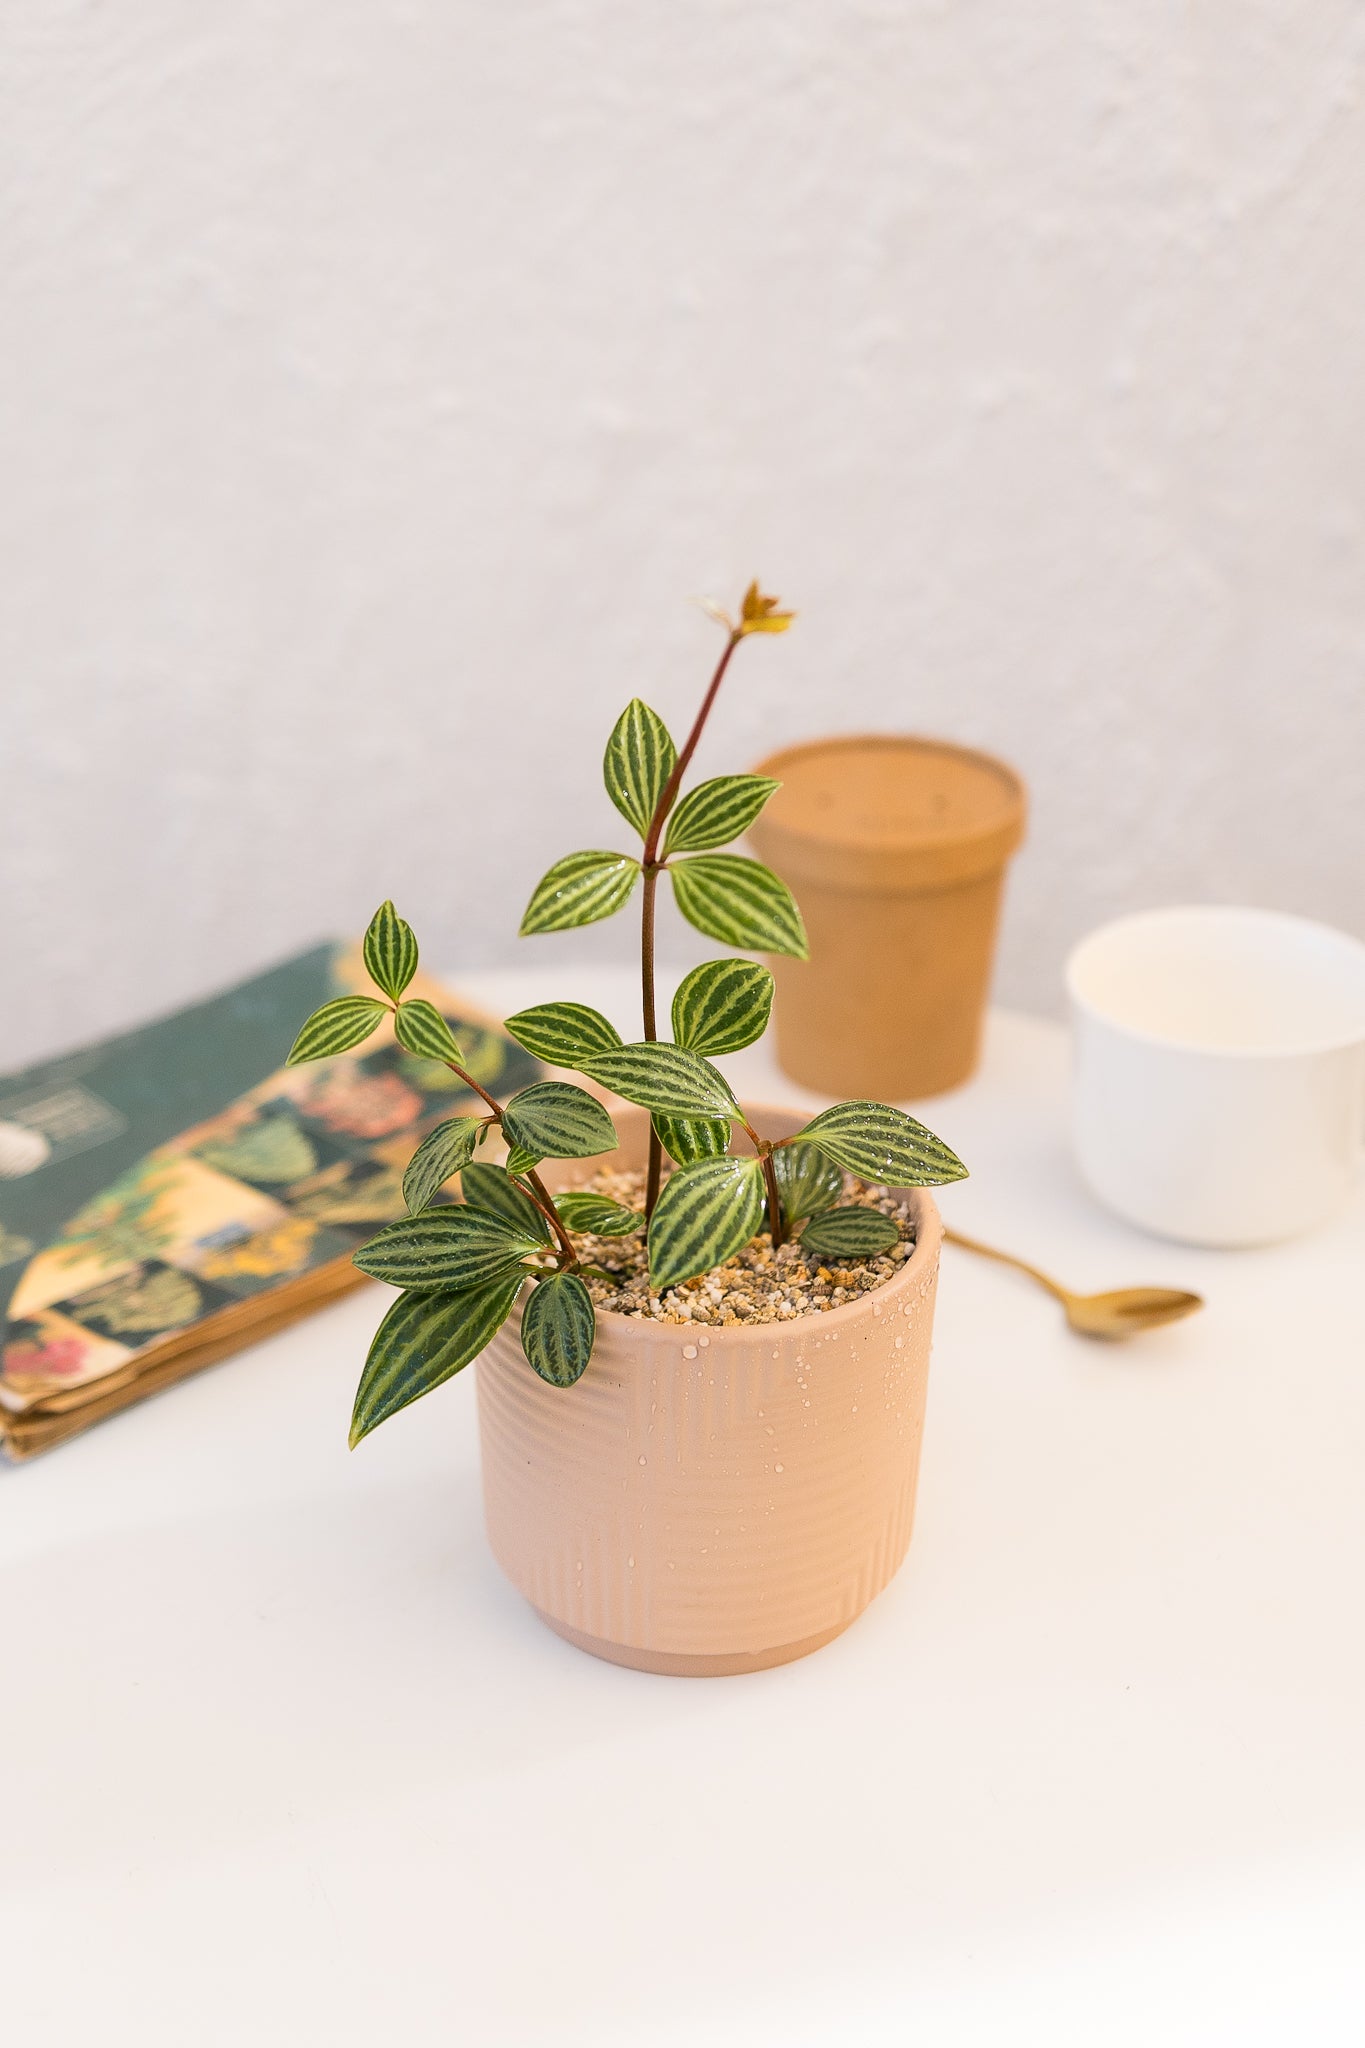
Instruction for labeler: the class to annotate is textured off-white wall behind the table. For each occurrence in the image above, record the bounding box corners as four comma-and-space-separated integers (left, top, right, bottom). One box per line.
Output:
0, 0, 1365, 1059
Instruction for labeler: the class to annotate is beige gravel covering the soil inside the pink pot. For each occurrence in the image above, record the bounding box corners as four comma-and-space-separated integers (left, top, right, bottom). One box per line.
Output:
573, 1171, 915, 1327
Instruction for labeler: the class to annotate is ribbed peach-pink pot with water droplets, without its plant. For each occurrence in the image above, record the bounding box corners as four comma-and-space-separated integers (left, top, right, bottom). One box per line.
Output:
477, 1110, 941, 1677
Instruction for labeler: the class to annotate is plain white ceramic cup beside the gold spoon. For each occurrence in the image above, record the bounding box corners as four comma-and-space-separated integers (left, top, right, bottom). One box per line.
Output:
1066, 905, 1365, 1245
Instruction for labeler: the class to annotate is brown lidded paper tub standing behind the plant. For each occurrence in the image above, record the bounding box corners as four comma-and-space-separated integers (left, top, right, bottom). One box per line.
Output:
749, 735, 1023, 1102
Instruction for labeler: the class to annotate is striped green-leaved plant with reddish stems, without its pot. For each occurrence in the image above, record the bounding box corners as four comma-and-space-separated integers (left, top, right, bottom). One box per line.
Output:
289, 584, 966, 1444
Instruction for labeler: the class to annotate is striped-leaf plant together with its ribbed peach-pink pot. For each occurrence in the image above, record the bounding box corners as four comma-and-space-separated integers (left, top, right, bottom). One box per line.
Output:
291, 584, 966, 1675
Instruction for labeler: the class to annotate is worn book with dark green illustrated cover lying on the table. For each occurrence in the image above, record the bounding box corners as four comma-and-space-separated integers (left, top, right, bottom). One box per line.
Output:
0, 942, 546, 1458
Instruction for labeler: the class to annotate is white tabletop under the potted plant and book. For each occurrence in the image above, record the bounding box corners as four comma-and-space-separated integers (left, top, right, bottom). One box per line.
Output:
0, 966, 1365, 2048
